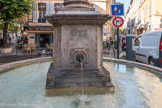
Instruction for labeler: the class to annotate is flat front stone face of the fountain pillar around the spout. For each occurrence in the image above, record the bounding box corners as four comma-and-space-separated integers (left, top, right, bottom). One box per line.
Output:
61, 25, 98, 69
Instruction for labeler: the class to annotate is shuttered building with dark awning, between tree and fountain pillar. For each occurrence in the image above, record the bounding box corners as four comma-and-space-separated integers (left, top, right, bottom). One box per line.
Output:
25, 0, 63, 47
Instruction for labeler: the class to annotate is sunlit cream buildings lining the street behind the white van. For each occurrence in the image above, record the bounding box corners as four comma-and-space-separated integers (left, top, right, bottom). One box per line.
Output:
124, 0, 162, 35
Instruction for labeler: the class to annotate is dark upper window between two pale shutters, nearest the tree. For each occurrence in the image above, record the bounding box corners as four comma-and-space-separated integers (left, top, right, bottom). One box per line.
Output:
38, 3, 46, 23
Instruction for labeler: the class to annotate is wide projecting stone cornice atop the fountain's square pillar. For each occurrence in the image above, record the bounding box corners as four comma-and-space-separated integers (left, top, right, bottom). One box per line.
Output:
46, 11, 112, 25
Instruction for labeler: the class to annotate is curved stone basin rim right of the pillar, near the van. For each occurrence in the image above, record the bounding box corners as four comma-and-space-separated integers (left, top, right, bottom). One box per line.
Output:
103, 57, 162, 75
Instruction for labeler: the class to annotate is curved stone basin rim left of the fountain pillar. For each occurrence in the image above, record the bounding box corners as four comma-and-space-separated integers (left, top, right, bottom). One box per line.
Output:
0, 57, 52, 74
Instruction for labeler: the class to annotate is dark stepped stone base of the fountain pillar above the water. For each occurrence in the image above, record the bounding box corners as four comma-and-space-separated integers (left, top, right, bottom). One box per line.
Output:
46, 63, 114, 95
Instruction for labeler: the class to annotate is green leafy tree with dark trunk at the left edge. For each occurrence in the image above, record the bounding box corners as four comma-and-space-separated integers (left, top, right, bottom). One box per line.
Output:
0, 0, 32, 48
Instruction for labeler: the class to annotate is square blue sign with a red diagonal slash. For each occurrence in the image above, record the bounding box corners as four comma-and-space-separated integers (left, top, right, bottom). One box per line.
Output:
111, 4, 124, 16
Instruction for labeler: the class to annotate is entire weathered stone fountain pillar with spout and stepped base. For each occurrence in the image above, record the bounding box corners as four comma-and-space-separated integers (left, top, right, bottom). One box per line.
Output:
46, 0, 113, 93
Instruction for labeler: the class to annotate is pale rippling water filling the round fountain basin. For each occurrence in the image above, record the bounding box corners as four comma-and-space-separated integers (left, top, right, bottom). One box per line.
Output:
0, 62, 162, 108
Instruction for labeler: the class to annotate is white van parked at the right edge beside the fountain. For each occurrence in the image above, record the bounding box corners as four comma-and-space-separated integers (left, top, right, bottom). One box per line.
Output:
133, 31, 162, 67
